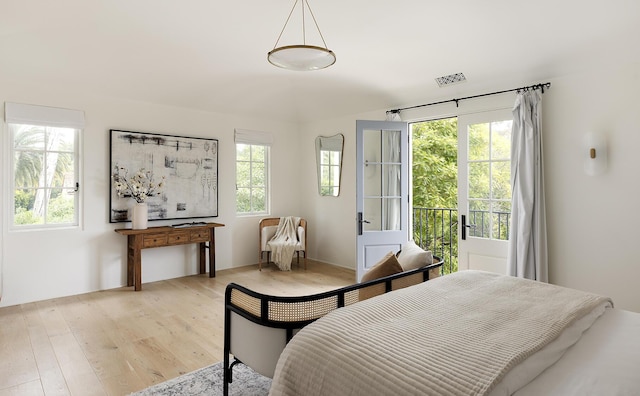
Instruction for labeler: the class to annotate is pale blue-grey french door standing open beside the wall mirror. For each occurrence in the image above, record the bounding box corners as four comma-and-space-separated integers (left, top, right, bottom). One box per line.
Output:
356, 121, 409, 282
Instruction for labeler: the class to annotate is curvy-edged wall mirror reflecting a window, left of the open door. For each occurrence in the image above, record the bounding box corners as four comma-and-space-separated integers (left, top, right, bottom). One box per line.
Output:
316, 133, 344, 197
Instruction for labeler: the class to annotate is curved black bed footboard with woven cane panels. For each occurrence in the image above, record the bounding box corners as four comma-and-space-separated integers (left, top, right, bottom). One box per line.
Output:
223, 257, 443, 396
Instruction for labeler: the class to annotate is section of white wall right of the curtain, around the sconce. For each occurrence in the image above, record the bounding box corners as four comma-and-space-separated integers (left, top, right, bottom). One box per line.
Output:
543, 63, 640, 312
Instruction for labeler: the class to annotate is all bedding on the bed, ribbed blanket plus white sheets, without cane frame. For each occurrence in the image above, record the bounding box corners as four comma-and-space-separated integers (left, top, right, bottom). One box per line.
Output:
222, 271, 640, 396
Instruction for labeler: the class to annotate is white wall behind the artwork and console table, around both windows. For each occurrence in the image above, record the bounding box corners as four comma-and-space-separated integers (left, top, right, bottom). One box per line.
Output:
0, 84, 301, 306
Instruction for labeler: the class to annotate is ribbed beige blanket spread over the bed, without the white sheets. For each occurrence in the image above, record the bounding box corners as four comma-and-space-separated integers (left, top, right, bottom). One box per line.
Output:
270, 271, 610, 396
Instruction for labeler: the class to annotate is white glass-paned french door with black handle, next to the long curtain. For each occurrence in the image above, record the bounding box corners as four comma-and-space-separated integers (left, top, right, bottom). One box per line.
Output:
458, 109, 513, 274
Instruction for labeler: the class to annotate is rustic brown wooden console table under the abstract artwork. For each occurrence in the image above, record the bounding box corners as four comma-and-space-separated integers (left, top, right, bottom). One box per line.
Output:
115, 223, 224, 291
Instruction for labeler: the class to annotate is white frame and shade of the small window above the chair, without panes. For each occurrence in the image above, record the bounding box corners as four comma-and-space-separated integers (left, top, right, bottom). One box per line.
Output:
235, 129, 273, 216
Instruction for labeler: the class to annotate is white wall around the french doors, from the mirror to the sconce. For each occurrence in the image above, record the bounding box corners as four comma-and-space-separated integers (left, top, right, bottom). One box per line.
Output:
303, 64, 640, 312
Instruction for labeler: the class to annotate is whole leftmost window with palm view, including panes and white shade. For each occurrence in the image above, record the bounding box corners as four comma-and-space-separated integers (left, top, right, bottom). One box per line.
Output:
5, 103, 84, 229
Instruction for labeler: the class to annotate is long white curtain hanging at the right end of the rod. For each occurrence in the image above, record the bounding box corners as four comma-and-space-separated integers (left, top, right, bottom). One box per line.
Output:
507, 90, 549, 282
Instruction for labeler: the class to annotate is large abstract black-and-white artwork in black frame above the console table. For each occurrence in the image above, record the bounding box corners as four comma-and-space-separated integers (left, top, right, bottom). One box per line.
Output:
109, 129, 218, 223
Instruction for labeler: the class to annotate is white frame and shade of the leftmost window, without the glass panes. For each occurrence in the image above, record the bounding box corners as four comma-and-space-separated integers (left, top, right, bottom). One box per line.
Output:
5, 102, 84, 231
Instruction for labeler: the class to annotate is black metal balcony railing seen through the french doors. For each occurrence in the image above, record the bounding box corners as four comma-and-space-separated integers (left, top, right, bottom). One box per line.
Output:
413, 208, 511, 274
